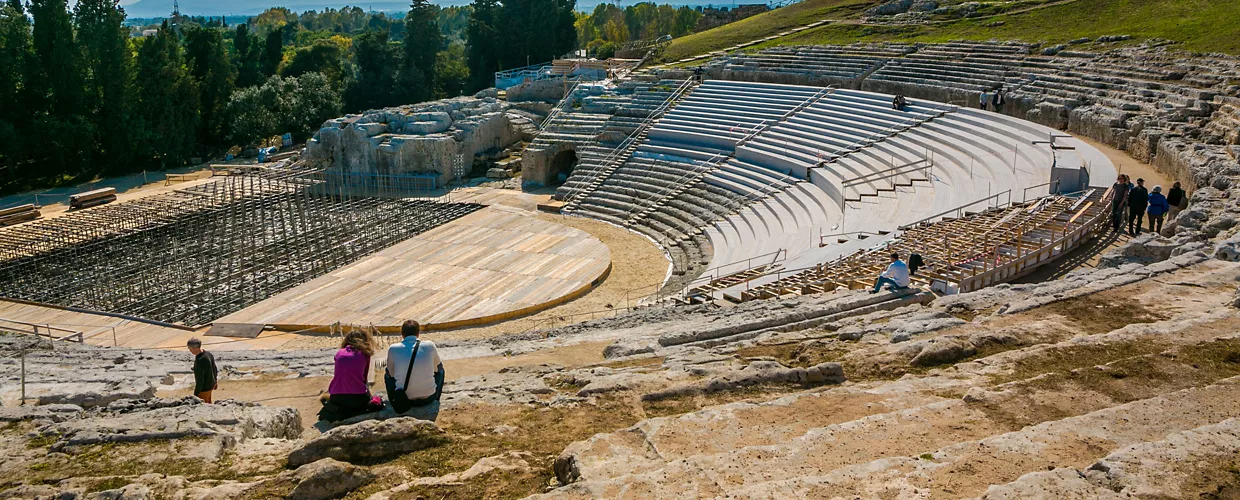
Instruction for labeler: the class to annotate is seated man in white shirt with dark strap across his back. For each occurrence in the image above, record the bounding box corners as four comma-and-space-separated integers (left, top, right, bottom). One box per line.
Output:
383, 320, 444, 413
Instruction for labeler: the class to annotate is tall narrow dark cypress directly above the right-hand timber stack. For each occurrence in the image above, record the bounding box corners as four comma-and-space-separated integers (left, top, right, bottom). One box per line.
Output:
74, 0, 134, 172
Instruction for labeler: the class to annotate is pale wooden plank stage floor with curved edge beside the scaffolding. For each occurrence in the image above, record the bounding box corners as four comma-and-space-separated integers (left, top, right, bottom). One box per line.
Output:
217, 205, 611, 330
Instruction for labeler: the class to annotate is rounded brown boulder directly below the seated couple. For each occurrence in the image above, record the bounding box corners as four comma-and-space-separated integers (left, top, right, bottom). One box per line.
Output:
289, 417, 444, 467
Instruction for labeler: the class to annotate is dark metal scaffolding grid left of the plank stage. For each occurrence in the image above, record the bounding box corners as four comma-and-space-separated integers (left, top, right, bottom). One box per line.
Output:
0, 169, 481, 325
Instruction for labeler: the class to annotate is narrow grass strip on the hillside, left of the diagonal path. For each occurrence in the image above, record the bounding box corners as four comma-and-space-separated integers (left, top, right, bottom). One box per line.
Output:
660, 0, 873, 61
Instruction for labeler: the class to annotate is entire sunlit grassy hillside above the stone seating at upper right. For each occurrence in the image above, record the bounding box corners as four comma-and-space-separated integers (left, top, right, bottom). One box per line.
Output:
663, 0, 1240, 61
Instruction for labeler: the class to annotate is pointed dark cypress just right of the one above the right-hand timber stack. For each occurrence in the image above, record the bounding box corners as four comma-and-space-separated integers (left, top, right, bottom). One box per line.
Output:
136, 21, 198, 165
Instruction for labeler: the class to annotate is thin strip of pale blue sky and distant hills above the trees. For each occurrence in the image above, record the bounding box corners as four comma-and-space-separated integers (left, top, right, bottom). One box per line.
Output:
122, 0, 766, 19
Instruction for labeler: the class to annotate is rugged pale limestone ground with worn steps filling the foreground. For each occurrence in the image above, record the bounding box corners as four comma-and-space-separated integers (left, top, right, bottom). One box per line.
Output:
0, 229, 1240, 499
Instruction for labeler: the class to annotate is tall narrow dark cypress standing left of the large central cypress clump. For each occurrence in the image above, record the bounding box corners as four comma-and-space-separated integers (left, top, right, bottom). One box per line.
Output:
401, 0, 444, 103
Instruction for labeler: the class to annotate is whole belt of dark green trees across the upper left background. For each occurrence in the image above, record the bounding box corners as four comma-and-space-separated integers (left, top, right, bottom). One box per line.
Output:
0, 0, 696, 194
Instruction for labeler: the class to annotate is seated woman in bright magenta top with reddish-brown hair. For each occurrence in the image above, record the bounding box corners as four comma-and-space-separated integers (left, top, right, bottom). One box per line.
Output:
319, 330, 383, 422
